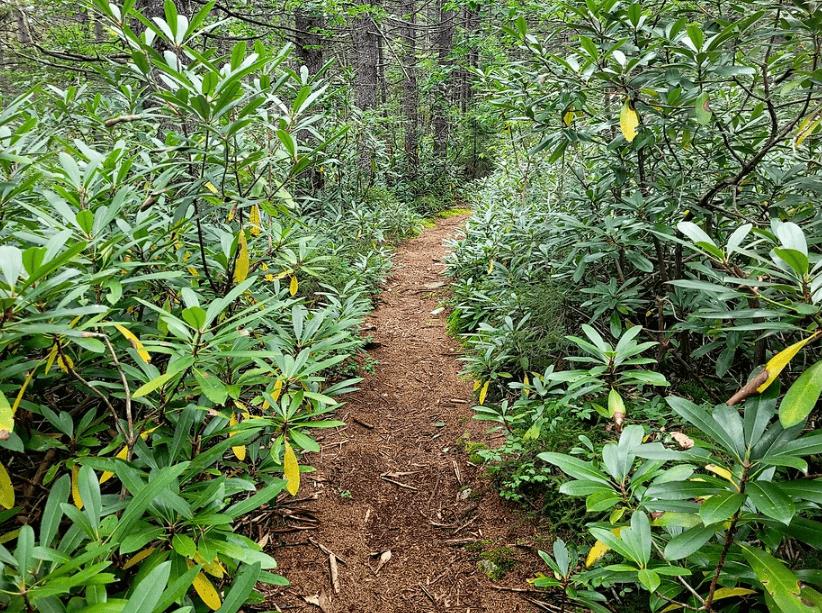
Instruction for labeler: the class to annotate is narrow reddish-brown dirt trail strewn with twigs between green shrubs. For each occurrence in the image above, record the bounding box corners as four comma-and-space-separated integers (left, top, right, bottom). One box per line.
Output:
271, 218, 536, 613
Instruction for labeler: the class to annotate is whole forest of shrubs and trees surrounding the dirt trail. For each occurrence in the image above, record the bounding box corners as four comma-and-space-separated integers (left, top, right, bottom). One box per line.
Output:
0, 0, 822, 611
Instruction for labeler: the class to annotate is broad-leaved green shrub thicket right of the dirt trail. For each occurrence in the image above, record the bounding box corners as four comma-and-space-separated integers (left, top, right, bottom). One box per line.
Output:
449, 0, 822, 611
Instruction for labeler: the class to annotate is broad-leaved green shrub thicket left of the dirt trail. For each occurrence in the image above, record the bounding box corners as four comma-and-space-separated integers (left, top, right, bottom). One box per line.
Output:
0, 0, 464, 613
